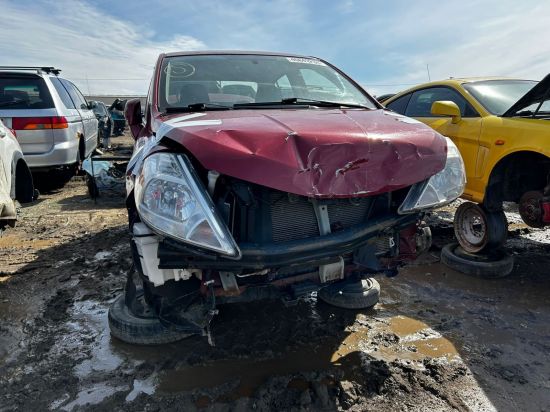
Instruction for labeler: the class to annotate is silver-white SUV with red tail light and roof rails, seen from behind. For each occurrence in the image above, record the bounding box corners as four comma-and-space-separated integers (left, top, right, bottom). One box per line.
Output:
0, 67, 97, 171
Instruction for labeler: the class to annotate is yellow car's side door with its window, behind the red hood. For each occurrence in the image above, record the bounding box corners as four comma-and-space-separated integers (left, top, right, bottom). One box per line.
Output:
405, 86, 482, 178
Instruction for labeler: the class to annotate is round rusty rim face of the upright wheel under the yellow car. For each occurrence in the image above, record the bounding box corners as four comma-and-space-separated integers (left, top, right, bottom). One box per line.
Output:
455, 205, 487, 252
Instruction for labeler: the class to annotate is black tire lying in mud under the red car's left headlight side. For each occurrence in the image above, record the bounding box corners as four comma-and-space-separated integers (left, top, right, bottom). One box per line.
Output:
109, 294, 193, 345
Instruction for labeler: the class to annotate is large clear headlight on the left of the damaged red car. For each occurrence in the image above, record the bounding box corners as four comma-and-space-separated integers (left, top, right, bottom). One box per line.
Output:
134, 153, 240, 257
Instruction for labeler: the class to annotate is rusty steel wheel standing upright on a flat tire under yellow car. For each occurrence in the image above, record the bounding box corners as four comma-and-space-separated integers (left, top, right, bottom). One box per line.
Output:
454, 202, 508, 253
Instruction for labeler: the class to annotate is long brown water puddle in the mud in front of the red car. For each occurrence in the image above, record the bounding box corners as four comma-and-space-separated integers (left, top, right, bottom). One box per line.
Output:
156, 316, 459, 406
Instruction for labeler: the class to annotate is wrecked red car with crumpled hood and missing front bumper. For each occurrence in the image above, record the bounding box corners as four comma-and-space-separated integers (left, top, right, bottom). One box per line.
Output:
109, 51, 465, 344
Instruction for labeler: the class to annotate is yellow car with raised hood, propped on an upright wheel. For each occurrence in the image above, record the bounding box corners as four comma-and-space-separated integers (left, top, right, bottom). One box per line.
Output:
384, 75, 550, 253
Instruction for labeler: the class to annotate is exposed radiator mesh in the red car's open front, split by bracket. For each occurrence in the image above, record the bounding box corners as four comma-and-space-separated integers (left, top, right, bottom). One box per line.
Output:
269, 192, 371, 243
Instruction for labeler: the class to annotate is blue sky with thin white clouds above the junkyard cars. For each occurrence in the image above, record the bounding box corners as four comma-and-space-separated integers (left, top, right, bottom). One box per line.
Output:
0, 0, 550, 94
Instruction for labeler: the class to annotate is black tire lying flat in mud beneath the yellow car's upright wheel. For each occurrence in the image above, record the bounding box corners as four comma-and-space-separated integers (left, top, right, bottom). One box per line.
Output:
441, 243, 514, 279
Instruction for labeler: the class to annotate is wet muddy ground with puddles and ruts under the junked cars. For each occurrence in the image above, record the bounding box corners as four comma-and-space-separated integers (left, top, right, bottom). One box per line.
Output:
0, 134, 550, 411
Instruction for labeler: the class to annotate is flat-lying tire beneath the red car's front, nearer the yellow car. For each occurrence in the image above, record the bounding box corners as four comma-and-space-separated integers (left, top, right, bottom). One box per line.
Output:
317, 278, 380, 309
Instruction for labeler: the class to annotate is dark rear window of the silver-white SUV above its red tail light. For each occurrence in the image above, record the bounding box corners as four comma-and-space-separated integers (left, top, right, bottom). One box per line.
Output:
0, 75, 54, 110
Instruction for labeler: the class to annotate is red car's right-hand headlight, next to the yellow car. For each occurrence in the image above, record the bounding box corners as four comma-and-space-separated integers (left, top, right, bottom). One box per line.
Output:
398, 137, 466, 214
